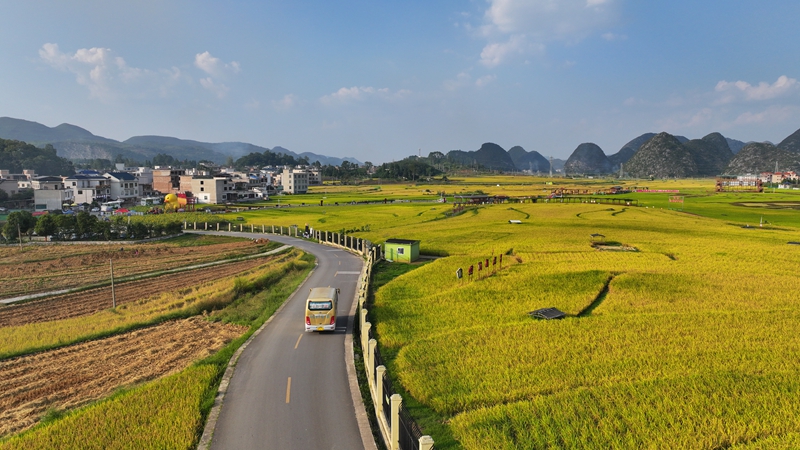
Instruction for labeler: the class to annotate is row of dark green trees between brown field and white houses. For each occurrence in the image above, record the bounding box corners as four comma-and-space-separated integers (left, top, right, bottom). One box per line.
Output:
2, 211, 182, 242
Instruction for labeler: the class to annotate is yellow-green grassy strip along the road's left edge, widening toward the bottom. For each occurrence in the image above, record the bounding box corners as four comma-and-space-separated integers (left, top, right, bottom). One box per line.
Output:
0, 251, 314, 450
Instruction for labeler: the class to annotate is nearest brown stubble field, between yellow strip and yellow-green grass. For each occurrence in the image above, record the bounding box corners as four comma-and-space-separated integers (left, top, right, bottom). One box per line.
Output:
0, 317, 246, 436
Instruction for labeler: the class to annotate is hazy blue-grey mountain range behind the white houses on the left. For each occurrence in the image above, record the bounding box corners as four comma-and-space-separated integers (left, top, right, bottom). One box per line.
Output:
0, 117, 361, 165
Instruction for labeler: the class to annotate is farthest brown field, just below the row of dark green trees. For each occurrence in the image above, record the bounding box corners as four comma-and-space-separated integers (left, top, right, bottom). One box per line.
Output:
0, 241, 266, 298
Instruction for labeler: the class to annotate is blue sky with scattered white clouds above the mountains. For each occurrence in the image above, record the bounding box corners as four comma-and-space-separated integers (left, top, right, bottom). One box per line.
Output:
0, 0, 800, 163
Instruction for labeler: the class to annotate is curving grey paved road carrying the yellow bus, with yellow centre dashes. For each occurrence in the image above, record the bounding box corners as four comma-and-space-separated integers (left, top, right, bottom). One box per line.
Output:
202, 233, 364, 450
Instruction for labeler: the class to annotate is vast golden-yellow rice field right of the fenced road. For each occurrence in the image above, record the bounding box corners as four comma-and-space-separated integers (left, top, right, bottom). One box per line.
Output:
227, 177, 800, 449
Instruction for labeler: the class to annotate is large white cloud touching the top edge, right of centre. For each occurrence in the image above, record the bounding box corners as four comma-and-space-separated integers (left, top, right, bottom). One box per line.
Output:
478, 0, 622, 67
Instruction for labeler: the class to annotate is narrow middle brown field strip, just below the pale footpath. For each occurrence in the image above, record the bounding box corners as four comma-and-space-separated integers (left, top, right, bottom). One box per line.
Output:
0, 258, 278, 327
